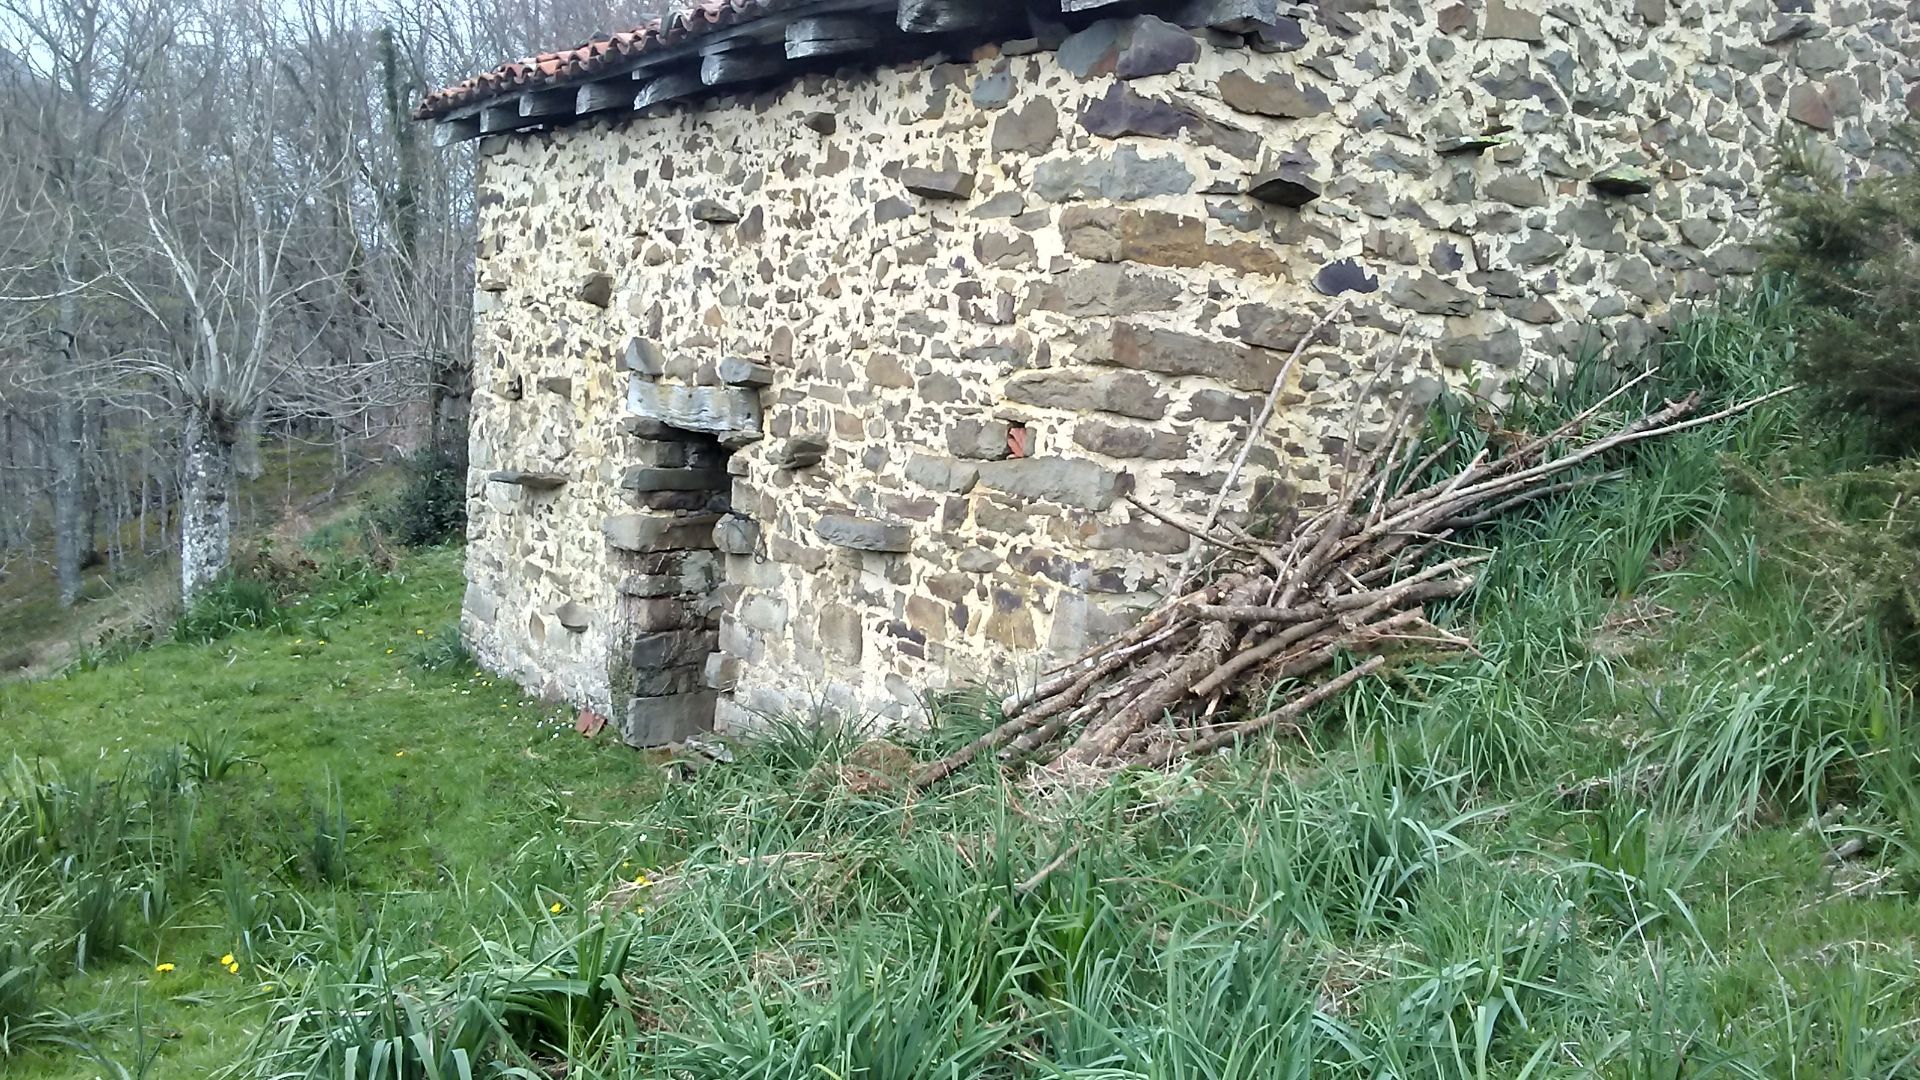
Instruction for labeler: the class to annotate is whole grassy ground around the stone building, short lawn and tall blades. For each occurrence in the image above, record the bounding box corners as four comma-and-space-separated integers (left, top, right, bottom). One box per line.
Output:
0, 290, 1920, 1080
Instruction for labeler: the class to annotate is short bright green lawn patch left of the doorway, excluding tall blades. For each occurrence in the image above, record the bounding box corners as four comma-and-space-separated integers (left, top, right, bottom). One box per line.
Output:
0, 550, 653, 1078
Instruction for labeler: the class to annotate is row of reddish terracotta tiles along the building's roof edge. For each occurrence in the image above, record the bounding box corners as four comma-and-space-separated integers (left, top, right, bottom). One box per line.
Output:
413, 0, 804, 119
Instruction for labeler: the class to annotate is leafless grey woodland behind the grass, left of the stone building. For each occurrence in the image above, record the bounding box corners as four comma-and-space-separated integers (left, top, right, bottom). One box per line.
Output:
0, 0, 670, 601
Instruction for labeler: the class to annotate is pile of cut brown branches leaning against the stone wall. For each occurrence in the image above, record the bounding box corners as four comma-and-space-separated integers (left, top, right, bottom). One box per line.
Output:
914, 371, 1788, 788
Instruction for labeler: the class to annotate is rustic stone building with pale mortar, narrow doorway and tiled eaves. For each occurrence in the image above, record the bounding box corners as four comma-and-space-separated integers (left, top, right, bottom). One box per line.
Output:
420, 0, 1920, 744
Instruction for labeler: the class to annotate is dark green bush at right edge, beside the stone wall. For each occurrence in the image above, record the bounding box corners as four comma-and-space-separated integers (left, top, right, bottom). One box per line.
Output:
1768, 131, 1920, 450
